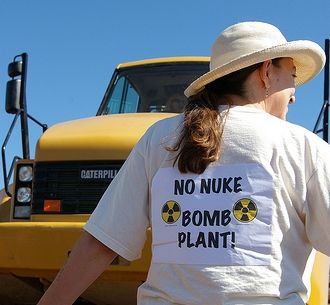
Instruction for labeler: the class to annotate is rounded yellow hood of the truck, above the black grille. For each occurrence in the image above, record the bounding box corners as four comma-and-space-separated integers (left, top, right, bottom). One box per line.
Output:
36, 113, 175, 161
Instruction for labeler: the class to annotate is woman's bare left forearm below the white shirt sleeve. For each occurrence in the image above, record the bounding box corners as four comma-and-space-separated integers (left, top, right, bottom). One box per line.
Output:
37, 232, 117, 305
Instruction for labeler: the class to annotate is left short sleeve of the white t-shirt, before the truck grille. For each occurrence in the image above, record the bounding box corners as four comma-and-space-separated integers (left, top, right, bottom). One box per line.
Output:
84, 137, 149, 261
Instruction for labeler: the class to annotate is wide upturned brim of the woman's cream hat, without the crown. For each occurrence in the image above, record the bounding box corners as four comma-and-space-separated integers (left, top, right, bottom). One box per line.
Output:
184, 40, 325, 97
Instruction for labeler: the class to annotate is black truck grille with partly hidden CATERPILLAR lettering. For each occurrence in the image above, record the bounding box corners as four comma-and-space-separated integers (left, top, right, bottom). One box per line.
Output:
32, 161, 124, 214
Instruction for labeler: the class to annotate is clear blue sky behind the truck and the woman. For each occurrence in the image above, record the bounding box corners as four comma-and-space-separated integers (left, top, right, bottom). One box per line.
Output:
0, 0, 330, 186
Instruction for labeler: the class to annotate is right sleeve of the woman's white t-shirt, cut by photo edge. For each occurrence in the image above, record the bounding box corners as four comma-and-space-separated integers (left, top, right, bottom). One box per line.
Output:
305, 142, 330, 256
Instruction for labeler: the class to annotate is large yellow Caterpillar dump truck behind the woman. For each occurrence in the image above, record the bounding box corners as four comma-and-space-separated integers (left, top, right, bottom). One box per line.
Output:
0, 53, 328, 305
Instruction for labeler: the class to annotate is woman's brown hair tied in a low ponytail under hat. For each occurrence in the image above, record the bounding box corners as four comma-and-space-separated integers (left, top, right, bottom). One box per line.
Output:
167, 59, 278, 174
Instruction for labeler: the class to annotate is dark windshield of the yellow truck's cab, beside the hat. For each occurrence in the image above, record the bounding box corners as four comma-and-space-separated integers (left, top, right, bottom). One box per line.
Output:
99, 61, 209, 115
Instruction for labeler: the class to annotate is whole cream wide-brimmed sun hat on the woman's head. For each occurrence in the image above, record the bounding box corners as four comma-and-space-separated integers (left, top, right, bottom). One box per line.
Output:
184, 22, 325, 97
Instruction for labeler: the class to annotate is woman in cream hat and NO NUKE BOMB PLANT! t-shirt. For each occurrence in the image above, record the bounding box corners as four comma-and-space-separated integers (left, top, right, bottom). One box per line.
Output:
39, 22, 330, 305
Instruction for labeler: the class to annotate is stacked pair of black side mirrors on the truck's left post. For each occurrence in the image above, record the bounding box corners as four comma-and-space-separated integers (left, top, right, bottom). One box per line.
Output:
6, 57, 23, 114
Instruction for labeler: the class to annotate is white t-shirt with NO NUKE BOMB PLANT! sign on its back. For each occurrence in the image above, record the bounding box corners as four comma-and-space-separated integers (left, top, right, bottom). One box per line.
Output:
85, 106, 330, 305
